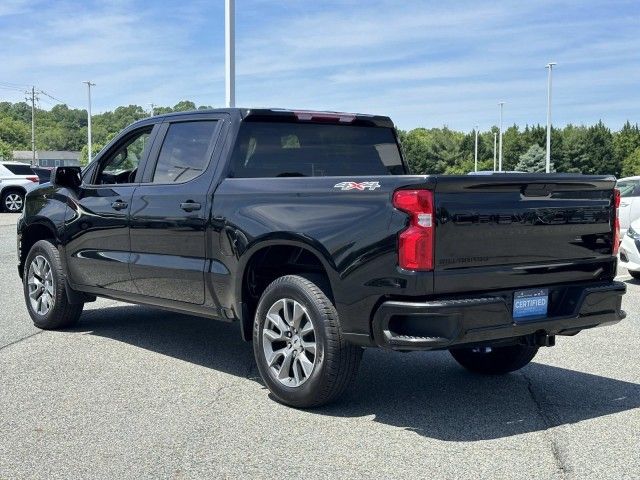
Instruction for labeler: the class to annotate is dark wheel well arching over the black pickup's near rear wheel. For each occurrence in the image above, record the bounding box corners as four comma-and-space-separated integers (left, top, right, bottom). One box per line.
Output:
241, 245, 333, 341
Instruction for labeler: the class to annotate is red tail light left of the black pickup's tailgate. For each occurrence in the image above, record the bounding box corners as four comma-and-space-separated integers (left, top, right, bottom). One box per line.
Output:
393, 190, 434, 270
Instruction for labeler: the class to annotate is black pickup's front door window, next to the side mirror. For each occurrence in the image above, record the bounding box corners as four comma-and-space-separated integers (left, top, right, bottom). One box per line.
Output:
96, 126, 153, 185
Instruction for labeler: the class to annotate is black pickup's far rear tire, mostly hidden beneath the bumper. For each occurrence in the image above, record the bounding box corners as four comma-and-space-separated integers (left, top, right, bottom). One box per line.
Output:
449, 345, 538, 375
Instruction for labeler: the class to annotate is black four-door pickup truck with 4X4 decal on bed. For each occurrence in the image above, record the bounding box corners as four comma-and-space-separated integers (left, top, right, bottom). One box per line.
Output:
18, 109, 625, 407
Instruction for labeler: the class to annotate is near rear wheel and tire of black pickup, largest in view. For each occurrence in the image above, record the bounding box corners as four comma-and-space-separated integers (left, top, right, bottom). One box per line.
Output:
253, 275, 362, 408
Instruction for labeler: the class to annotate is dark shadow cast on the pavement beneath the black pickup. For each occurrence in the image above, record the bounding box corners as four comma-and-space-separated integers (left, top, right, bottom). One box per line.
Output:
75, 306, 640, 441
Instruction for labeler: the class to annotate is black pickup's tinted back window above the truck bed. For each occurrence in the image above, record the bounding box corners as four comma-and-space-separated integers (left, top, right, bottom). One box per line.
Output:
231, 122, 405, 178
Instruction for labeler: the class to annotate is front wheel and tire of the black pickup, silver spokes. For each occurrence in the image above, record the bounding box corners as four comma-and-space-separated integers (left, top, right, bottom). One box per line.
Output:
22, 240, 84, 330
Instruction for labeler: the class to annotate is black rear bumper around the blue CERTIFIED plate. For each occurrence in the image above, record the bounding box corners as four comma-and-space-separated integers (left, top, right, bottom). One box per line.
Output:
372, 282, 626, 350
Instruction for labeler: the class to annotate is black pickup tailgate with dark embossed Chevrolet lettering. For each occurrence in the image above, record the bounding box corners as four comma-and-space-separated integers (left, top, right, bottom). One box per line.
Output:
434, 174, 616, 293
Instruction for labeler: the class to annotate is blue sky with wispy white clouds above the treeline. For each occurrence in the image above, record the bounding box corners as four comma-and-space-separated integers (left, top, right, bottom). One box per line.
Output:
0, 0, 640, 131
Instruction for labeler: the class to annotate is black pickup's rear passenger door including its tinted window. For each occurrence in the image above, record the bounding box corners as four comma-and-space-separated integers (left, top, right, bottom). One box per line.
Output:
131, 114, 225, 304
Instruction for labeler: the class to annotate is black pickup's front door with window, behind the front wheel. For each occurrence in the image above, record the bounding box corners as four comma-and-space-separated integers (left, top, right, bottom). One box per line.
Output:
65, 125, 153, 293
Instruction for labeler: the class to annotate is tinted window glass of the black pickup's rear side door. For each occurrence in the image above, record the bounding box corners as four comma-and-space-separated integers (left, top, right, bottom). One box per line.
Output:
152, 120, 217, 183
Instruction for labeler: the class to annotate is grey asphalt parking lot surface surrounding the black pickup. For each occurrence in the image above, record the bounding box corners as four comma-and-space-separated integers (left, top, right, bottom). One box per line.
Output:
0, 214, 640, 479
